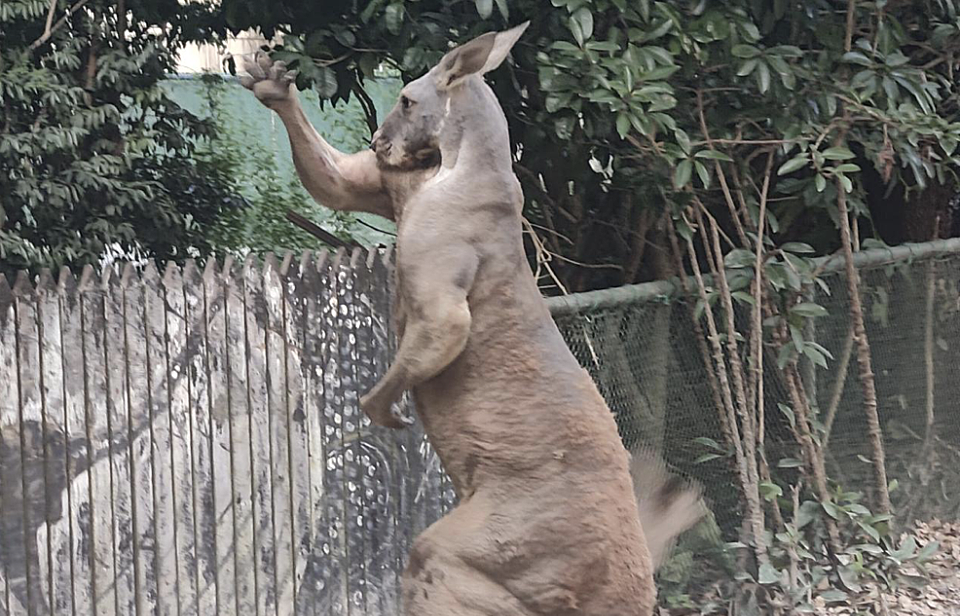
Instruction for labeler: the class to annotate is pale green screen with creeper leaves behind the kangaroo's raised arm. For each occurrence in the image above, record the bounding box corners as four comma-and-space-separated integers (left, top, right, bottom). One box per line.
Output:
175, 75, 397, 254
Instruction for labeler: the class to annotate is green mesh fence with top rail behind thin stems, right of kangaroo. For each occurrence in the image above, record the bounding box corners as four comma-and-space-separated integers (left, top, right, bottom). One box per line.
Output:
550, 240, 960, 540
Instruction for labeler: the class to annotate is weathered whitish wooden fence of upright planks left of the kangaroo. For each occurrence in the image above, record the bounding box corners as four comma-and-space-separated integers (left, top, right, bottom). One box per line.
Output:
0, 250, 452, 616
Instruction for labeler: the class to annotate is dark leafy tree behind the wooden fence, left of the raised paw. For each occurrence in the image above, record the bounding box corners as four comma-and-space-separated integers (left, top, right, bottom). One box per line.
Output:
0, 0, 243, 275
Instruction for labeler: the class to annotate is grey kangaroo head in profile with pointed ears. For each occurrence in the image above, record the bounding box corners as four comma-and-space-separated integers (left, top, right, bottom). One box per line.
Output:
371, 22, 529, 171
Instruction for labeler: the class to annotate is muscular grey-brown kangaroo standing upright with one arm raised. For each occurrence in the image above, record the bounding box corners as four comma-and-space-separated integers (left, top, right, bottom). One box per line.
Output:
243, 24, 699, 616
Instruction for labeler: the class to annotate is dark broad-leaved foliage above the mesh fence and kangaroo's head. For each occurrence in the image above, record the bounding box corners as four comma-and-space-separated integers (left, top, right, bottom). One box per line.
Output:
223, 0, 960, 290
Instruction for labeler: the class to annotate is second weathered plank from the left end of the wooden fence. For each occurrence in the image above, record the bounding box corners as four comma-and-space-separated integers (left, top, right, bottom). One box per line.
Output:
13, 272, 51, 615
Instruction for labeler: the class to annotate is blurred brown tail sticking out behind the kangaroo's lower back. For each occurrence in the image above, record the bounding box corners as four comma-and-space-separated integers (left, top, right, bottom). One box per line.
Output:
630, 451, 707, 570
